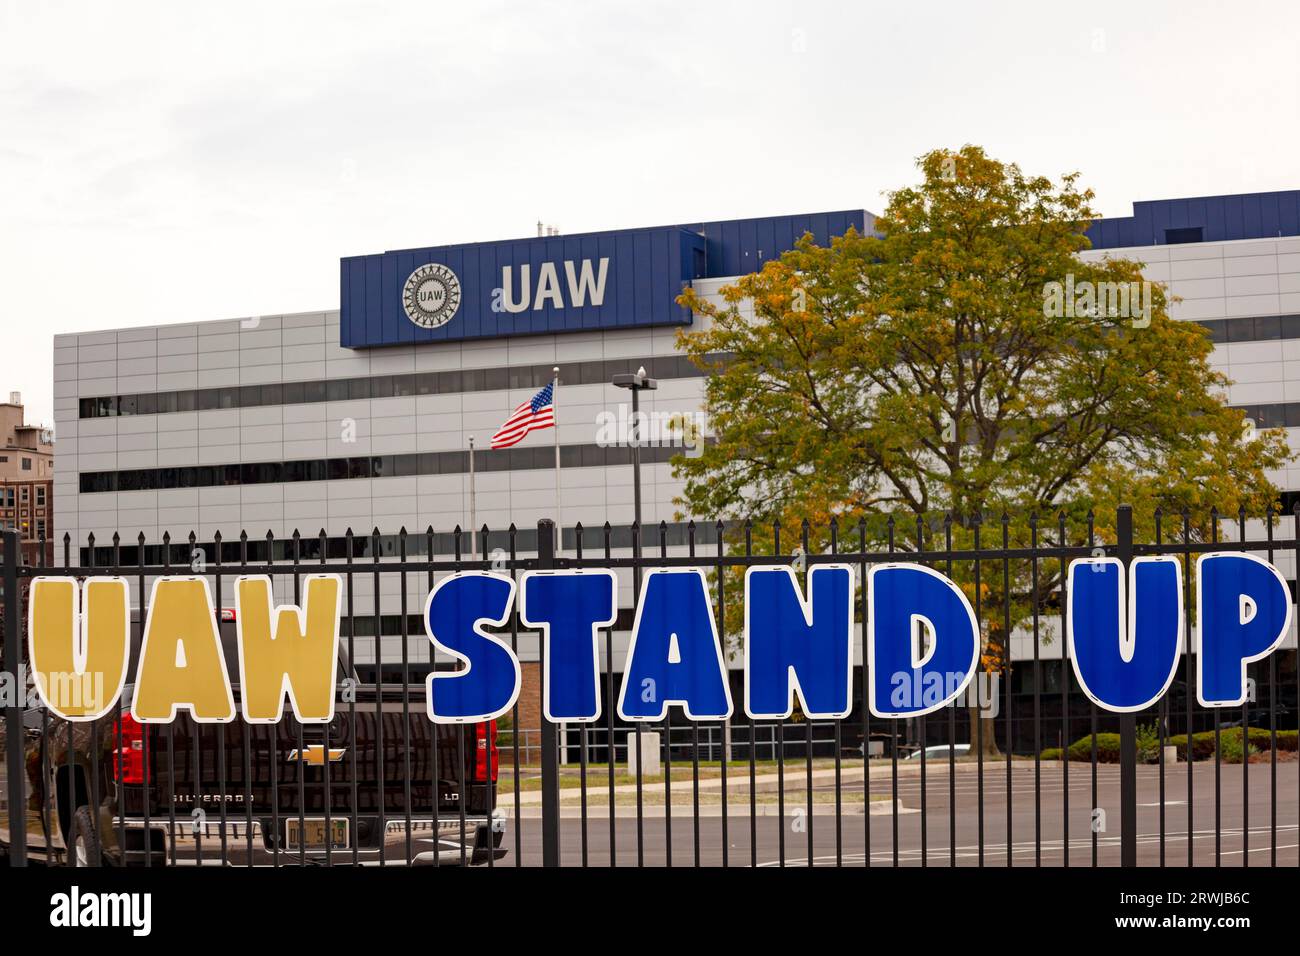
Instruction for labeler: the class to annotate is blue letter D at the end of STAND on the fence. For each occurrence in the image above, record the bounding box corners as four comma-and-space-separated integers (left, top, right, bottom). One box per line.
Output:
867, 564, 979, 717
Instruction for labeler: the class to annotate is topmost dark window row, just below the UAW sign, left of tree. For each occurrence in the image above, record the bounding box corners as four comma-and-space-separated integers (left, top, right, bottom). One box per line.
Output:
79, 355, 733, 419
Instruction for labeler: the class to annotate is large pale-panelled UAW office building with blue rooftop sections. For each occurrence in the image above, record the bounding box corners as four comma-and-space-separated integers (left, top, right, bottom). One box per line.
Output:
55, 191, 1300, 726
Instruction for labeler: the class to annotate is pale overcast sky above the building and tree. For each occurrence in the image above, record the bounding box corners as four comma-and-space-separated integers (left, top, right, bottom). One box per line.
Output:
0, 0, 1300, 423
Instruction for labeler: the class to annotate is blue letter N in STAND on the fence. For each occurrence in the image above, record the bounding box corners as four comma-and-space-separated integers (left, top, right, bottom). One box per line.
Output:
745, 564, 853, 721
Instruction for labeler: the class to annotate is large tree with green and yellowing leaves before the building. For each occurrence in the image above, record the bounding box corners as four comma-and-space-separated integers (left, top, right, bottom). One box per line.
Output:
676, 146, 1291, 749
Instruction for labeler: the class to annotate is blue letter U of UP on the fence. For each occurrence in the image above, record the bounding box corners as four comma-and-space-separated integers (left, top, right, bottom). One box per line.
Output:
1066, 555, 1183, 714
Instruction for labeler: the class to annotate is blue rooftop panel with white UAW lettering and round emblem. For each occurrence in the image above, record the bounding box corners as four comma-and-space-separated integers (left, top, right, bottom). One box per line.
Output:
339, 211, 872, 349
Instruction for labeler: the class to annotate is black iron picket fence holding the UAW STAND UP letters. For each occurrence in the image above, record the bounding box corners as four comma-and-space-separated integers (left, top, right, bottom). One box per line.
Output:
0, 507, 1300, 866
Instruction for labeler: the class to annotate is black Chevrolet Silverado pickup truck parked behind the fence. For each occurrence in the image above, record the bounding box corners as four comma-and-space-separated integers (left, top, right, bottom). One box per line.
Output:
0, 611, 506, 866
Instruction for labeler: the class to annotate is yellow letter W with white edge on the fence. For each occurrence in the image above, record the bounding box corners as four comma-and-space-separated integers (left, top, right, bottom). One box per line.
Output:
235, 575, 343, 723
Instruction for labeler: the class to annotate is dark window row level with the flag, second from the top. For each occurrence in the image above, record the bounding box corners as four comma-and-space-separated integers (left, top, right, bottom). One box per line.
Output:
81, 445, 683, 494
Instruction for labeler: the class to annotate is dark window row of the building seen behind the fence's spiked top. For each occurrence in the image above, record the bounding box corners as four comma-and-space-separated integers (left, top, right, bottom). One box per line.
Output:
78, 522, 718, 571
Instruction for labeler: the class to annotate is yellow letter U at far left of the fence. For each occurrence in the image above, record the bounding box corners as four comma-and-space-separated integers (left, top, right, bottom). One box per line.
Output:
27, 578, 131, 721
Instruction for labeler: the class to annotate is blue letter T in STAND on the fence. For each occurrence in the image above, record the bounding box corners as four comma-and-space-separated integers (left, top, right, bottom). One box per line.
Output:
519, 570, 619, 723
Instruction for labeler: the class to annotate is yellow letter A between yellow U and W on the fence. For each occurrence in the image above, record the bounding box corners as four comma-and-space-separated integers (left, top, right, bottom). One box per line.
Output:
131, 578, 235, 723
